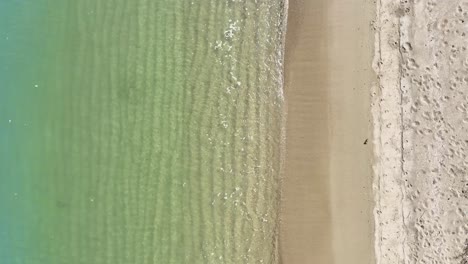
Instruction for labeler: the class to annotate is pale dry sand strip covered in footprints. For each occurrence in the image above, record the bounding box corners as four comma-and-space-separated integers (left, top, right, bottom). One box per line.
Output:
372, 0, 468, 264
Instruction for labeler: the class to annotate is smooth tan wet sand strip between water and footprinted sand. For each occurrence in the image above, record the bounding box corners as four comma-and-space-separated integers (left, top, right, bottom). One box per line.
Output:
280, 0, 374, 264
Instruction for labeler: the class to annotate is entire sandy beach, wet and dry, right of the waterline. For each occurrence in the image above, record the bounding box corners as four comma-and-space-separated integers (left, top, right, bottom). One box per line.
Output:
280, 0, 468, 264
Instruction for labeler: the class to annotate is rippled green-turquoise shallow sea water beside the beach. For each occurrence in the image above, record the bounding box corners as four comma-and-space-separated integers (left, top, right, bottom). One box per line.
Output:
0, 0, 286, 264
